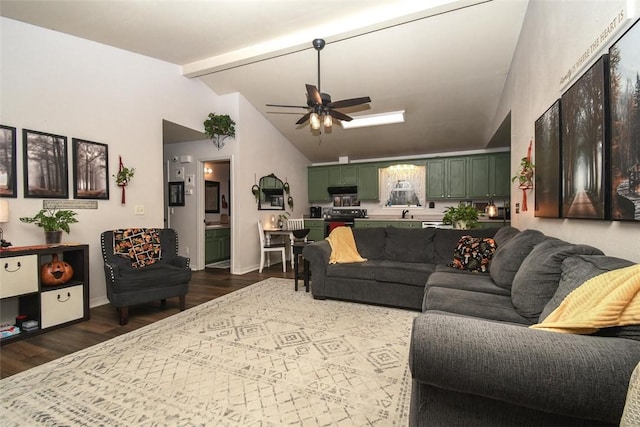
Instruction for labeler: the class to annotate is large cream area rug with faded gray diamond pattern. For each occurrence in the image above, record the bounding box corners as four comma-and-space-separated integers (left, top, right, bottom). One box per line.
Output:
0, 278, 417, 427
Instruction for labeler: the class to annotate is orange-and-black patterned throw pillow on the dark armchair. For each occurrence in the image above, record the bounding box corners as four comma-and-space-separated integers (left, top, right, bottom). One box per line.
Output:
113, 228, 161, 268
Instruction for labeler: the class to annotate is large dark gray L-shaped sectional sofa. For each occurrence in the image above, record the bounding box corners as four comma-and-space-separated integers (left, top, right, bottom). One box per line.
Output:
303, 227, 640, 426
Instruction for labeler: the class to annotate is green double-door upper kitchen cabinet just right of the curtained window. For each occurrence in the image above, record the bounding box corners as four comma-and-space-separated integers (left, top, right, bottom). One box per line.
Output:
427, 157, 467, 199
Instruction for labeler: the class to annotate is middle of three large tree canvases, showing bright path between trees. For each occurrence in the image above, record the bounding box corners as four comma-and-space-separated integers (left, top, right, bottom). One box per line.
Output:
564, 55, 608, 219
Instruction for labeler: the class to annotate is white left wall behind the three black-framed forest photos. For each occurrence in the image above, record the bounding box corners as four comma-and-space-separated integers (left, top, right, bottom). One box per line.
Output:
0, 18, 218, 306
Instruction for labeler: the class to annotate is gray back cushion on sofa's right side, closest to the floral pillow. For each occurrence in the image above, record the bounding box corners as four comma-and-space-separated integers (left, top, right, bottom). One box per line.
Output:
489, 230, 546, 289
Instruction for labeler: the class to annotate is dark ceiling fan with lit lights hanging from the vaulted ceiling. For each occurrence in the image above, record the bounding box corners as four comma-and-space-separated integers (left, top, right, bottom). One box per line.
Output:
267, 39, 371, 130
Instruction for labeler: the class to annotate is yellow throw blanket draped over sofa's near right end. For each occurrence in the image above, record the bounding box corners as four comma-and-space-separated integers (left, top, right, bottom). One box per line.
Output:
531, 264, 640, 334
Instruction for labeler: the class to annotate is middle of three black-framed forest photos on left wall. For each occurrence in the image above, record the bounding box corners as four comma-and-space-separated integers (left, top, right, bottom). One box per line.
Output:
22, 129, 69, 199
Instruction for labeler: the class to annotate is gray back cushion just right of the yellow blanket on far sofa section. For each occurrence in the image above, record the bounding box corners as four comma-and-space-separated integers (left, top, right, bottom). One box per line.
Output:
385, 227, 436, 263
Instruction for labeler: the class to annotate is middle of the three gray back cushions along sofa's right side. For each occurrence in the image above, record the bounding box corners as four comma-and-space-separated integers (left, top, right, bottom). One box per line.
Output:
511, 237, 602, 321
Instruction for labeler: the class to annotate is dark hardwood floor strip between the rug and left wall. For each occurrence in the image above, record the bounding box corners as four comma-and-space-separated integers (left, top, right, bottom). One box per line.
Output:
0, 264, 296, 378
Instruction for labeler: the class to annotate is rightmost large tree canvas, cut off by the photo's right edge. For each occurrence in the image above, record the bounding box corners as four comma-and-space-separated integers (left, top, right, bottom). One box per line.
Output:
609, 18, 640, 221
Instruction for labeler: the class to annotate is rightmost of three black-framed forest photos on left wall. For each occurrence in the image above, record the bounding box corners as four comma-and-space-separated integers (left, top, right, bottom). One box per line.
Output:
71, 138, 109, 200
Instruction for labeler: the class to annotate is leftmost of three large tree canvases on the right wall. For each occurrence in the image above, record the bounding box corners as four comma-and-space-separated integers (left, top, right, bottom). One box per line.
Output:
534, 99, 562, 218
